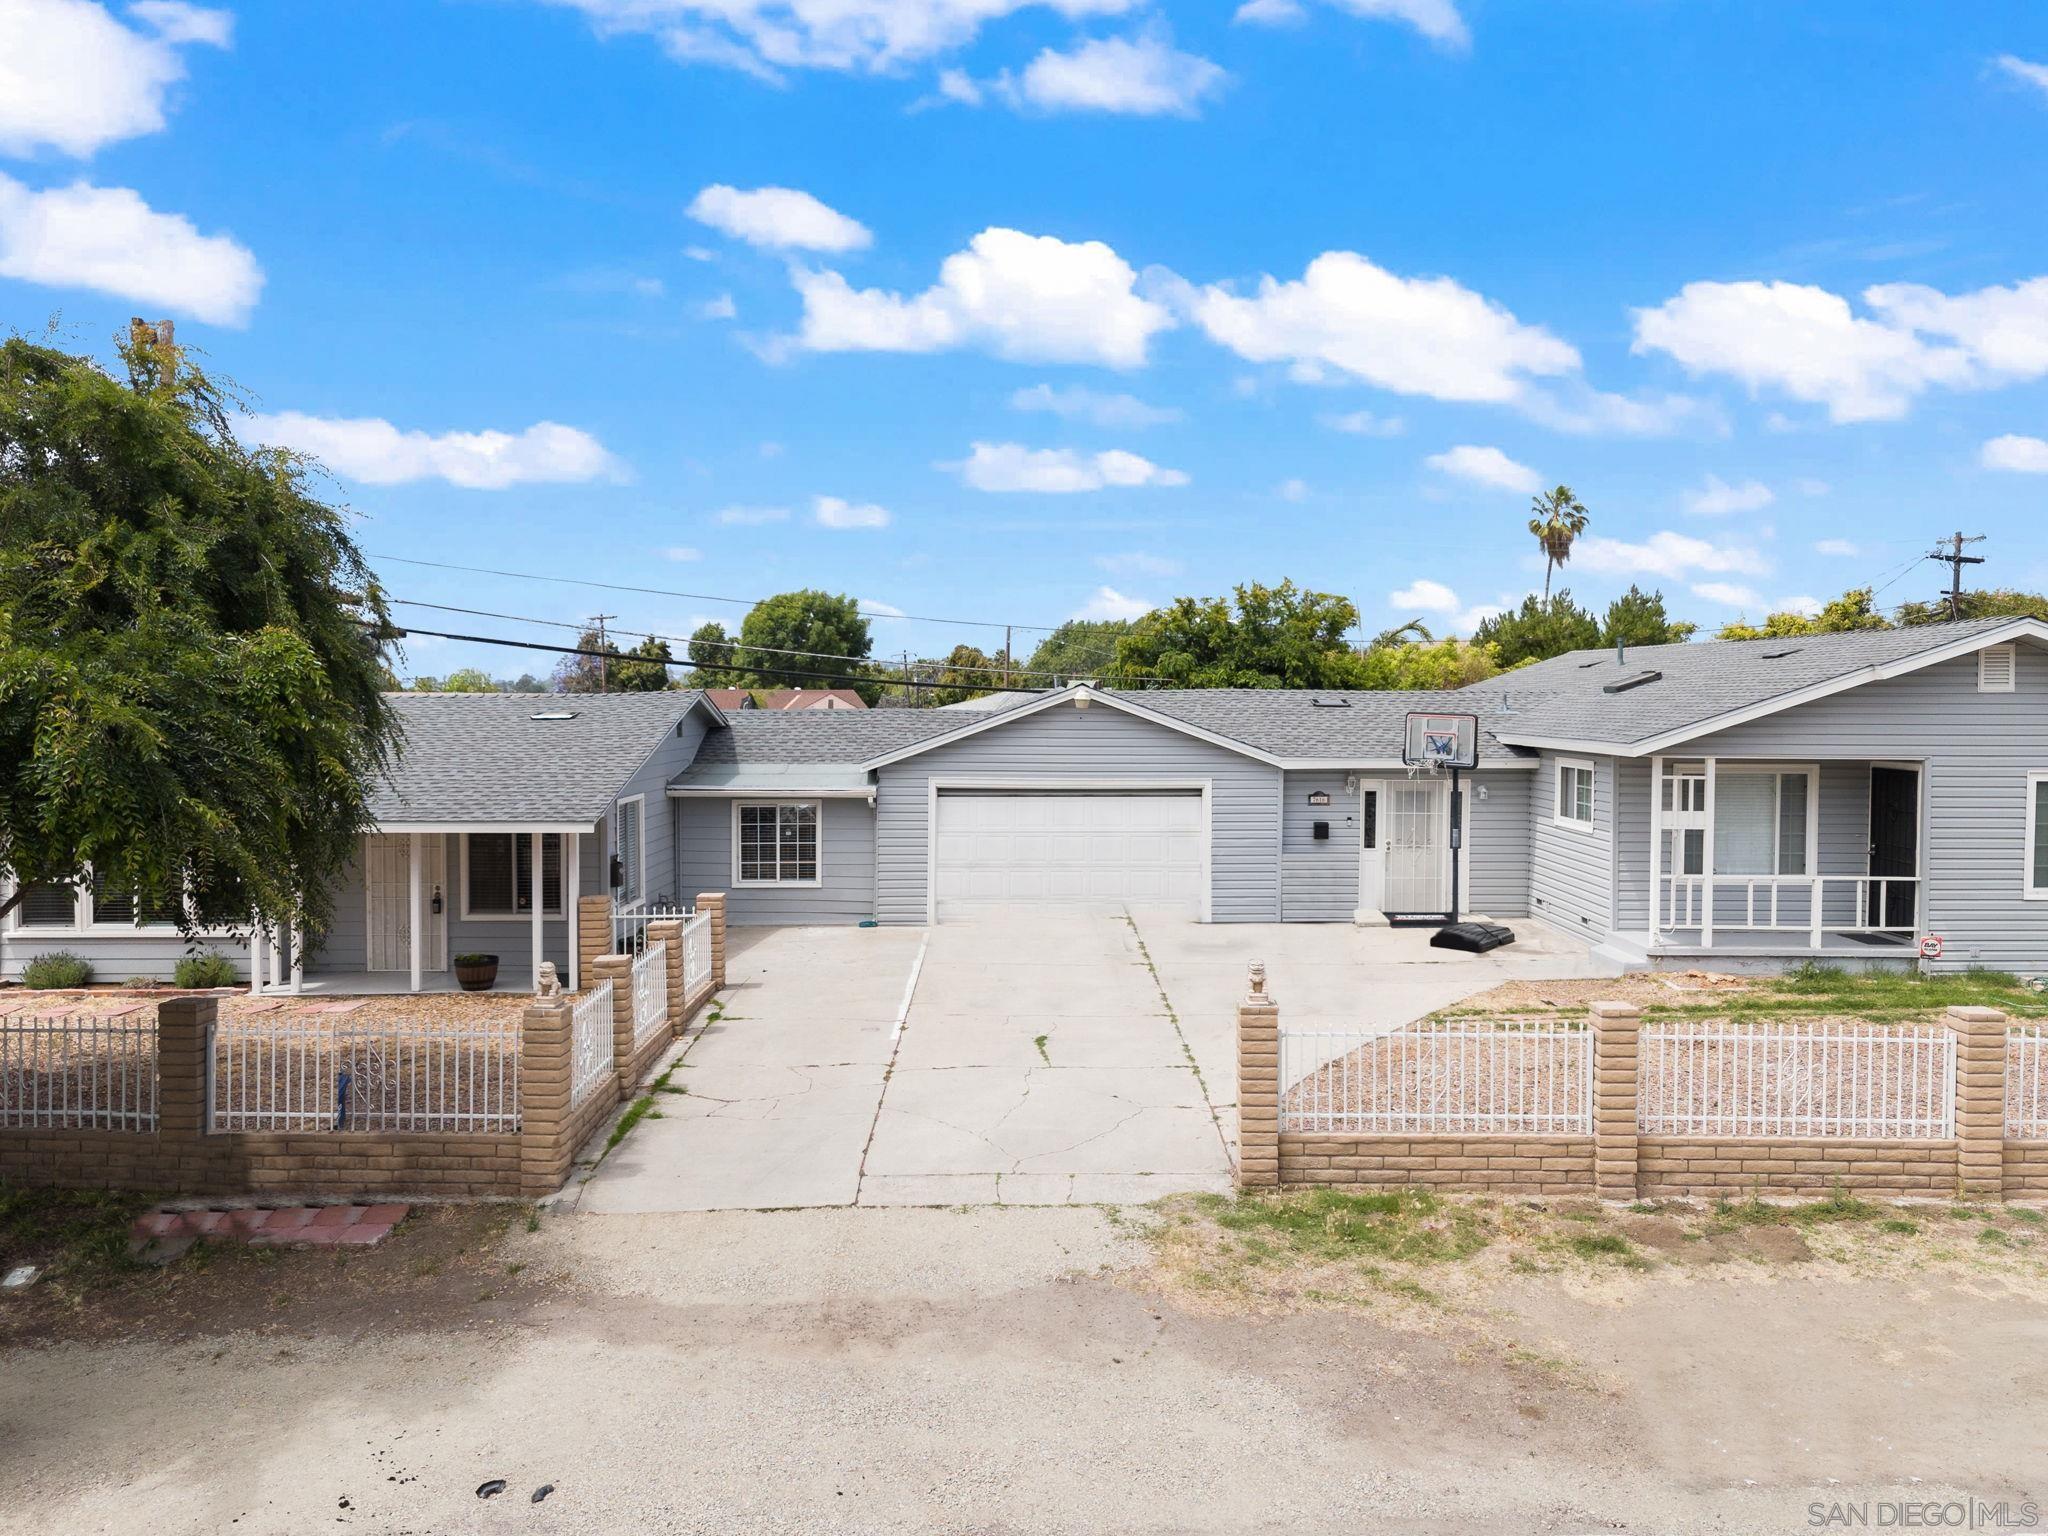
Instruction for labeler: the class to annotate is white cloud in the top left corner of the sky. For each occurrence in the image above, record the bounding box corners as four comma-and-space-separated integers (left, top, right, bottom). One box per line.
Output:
0, 0, 233, 156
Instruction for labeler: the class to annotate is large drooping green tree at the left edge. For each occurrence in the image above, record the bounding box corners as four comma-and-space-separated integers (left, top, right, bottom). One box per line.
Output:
0, 322, 395, 932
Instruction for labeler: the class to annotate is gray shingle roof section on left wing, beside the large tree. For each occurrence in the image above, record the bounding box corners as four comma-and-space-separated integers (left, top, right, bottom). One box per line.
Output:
371, 690, 723, 825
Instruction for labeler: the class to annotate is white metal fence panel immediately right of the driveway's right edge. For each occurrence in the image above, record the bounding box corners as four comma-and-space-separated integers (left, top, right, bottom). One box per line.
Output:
1280, 1020, 1593, 1137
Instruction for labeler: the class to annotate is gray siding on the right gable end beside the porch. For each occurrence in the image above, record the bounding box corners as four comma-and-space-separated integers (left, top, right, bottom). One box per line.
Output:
1686, 643, 2048, 973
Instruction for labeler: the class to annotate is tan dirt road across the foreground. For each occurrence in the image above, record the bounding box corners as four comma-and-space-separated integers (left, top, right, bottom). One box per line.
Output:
0, 1208, 2048, 1536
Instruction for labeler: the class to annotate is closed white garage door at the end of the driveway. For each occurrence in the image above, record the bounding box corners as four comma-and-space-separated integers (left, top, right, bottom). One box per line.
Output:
934, 788, 1202, 918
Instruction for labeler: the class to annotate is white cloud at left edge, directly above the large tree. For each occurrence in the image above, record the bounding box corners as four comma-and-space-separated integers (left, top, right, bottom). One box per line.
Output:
0, 174, 262, 326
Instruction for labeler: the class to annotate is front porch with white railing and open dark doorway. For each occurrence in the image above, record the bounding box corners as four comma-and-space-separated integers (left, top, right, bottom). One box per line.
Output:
1616, 758, 1925, 963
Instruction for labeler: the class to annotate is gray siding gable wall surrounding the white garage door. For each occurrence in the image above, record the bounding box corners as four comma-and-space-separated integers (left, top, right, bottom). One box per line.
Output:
874, 705, 1280, 924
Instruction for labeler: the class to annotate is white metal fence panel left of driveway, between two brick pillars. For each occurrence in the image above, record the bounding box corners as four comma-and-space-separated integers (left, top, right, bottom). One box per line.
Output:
207, 1018, 520, 1133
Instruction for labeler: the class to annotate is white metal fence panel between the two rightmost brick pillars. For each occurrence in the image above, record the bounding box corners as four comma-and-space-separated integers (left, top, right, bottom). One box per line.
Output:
1636, 1020, 1956, 1141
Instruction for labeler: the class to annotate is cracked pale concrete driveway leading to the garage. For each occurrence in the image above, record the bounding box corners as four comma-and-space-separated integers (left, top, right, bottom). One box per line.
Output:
575, 911, 1597, 1212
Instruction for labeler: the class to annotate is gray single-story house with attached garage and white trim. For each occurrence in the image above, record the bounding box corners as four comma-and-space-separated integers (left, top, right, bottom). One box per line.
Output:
12, 618, 2048, 985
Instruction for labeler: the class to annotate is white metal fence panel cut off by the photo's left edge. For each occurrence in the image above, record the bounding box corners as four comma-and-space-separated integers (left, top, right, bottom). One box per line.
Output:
0, 1014, 156, 1130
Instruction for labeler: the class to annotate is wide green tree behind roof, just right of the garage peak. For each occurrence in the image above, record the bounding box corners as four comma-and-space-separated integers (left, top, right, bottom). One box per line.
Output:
1106, 582, 1364, 688
